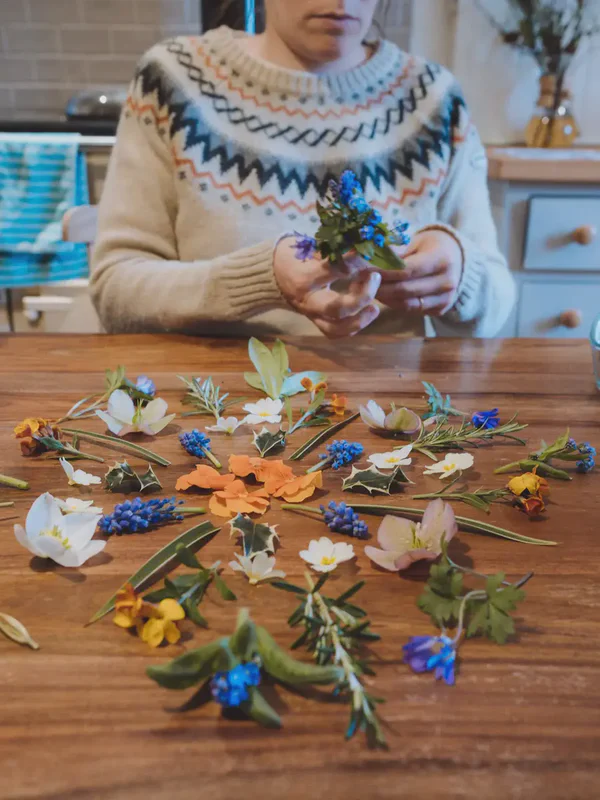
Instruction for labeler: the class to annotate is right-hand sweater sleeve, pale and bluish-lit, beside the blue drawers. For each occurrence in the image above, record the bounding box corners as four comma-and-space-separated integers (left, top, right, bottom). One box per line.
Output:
423, 111, 516, 337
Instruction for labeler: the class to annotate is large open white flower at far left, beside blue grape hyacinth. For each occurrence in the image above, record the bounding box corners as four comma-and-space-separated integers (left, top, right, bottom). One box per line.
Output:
15, 492, 106, 567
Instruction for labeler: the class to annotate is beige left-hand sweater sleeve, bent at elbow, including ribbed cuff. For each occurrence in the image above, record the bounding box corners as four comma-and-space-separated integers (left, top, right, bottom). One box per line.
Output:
91, 83, 285, 333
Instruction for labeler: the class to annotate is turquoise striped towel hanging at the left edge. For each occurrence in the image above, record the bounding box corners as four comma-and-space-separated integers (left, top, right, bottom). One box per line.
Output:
0, 133, 89, 288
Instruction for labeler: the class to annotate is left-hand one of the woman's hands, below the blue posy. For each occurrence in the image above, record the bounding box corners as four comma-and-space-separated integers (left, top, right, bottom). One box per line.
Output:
273, 237, 381, 339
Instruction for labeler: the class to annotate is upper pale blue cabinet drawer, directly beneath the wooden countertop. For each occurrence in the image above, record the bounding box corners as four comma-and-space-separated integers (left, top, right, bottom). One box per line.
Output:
523, 195, 600, 271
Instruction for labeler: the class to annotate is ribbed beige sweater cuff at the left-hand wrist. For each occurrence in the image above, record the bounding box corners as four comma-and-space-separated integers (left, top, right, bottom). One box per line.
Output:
216, 240, 287, 318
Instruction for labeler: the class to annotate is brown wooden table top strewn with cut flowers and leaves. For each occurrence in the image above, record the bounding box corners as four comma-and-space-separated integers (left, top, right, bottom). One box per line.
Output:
0, 336, 600, 800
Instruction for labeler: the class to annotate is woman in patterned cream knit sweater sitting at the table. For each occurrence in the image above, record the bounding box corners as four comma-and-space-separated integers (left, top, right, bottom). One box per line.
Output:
92, 0, 515, 337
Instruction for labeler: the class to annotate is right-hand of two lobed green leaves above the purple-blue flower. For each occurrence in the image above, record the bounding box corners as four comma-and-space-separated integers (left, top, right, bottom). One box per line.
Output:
467, 572, 526, 644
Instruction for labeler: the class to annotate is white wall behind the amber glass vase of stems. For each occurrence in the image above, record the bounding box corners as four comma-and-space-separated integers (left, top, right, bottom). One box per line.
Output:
411, 0, 600, 144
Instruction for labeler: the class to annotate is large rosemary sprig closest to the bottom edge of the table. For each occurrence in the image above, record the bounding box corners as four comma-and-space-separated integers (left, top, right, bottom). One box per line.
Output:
272, 573, 387, 749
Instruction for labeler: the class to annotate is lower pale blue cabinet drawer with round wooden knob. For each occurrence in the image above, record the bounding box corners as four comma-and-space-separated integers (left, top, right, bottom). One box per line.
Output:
518, 278, 600, 338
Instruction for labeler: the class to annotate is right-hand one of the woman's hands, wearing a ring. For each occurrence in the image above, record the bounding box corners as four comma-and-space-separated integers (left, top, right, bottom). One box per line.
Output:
377, 230, 463, 317
